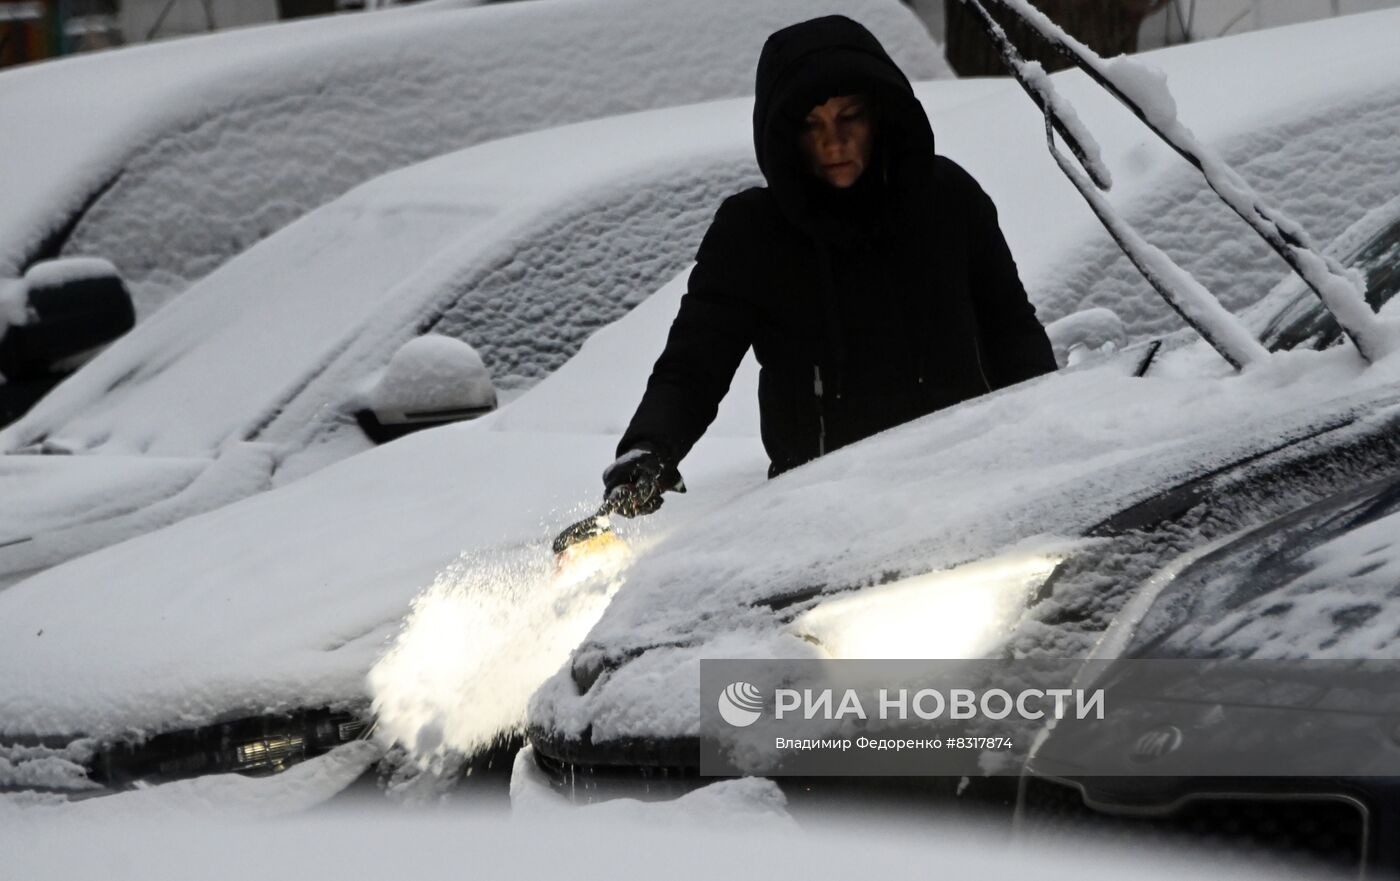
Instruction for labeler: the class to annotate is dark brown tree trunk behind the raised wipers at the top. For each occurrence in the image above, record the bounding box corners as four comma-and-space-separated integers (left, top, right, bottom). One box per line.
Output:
944, 0, 1166, 77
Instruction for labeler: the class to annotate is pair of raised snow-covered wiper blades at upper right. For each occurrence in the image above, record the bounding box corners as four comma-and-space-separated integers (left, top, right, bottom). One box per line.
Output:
963, 0, 1394, 367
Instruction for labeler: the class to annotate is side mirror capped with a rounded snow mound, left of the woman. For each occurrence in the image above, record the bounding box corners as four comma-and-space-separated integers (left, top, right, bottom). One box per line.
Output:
356, 333, 496, 444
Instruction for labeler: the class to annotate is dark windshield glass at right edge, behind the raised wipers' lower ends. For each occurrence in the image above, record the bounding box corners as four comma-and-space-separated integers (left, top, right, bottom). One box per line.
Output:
1246, 196, 1400, 352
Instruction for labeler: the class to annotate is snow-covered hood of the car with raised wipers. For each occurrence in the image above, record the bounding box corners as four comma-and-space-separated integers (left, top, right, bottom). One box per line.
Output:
531, 340, 1400, 742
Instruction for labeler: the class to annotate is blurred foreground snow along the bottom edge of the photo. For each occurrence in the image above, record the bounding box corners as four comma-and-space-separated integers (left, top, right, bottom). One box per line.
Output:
0, 773, 1306, 881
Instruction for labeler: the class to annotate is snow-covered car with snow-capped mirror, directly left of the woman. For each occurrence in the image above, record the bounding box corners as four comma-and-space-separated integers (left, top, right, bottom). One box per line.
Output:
0, 95, 772, 585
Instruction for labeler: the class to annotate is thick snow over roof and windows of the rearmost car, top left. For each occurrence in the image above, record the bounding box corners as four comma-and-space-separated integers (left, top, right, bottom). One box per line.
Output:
0, 0, 951, 318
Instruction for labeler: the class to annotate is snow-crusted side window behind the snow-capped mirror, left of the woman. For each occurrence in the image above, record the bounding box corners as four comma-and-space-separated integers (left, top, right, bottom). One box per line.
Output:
249, 155, 760, 479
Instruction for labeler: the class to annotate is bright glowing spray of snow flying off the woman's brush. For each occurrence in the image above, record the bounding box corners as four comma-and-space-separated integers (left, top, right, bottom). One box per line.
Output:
368, 526, 631, 770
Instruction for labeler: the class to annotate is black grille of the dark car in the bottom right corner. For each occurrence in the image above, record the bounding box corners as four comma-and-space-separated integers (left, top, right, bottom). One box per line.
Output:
1018, 777, 1368, 874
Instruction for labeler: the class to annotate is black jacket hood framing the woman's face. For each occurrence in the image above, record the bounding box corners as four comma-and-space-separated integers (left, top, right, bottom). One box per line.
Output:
753, 15, 934, 244
